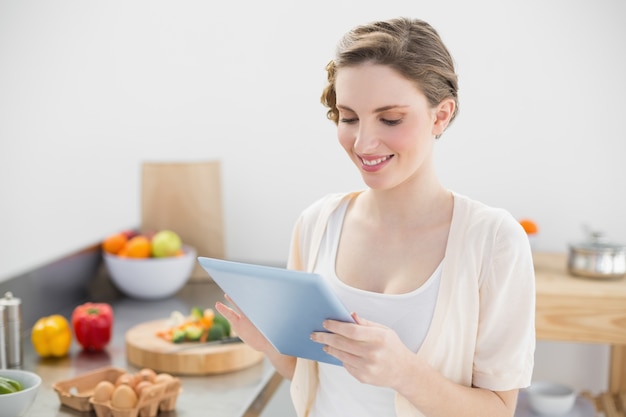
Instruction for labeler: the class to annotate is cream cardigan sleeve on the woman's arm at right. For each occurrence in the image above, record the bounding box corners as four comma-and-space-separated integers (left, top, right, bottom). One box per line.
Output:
472, 212, 535, 391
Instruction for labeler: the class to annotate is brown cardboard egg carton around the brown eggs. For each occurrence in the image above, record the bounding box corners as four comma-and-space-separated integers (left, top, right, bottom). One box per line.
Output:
52, 366, 181, 417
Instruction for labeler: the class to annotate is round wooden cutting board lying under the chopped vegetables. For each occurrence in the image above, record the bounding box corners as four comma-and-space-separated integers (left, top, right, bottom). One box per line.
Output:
125, 319, 263, 375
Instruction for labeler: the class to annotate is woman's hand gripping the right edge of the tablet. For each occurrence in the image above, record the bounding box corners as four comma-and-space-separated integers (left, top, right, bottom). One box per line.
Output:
311, 313, 415, 388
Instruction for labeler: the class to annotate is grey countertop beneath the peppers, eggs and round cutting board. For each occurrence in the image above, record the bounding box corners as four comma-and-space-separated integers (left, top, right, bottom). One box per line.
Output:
17, 281, 282, 417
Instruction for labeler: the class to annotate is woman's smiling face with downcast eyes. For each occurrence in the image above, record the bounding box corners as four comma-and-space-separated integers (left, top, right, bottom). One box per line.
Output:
335, 64, 447, 189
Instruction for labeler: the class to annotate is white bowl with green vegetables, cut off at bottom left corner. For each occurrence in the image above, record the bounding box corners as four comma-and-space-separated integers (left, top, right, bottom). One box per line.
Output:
0, 369, 41, 417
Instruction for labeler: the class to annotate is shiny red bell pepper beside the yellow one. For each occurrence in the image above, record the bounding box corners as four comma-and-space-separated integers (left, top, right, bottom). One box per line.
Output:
72, 303, 113, 351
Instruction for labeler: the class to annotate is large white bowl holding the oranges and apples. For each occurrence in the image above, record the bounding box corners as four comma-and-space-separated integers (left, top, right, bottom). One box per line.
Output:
104, 246, 196, 300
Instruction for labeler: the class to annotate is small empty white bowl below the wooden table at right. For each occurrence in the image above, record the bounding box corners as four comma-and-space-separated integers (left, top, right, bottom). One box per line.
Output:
526, 381, 576, 416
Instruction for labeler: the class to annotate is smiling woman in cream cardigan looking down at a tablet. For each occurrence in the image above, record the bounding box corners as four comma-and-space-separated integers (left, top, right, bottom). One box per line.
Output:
216, 18, 535, 417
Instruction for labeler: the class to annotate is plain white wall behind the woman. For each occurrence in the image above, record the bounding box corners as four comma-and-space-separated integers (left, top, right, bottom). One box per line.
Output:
0, 0, 626, 394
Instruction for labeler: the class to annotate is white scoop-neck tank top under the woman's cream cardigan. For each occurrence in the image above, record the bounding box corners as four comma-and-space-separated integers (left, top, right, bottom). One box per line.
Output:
310, 198, 441, 417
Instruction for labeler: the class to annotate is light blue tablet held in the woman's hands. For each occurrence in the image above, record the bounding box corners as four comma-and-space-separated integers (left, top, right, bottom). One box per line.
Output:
198, 257, 354, 365
